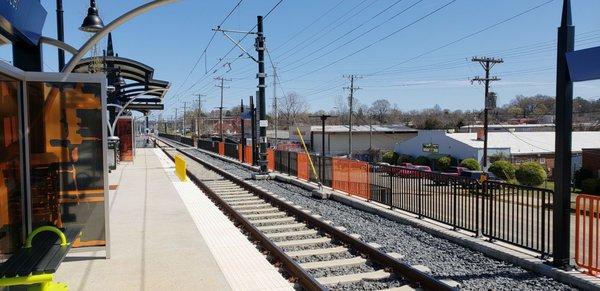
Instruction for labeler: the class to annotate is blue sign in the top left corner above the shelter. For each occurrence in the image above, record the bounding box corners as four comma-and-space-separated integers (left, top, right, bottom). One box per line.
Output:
0, 0, 48, 45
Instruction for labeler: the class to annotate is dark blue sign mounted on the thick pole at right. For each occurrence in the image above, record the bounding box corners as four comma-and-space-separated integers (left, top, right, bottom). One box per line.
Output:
567, 47, 600, 82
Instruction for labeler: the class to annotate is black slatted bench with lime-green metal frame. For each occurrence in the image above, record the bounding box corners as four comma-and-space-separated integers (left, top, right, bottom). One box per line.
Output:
0, 226, 81, 291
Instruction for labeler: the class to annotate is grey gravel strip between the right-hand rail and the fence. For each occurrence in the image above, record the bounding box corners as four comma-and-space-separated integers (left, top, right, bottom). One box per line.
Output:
180, 151, 573, 290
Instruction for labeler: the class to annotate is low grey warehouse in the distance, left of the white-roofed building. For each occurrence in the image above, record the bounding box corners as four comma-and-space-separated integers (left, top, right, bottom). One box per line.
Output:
290, 125, 417, 156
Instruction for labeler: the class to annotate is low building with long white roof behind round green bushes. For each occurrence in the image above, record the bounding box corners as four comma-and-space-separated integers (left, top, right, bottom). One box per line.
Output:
396, 130, 600, 173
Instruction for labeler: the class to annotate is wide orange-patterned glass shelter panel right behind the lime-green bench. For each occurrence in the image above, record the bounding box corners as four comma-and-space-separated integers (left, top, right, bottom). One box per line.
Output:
27, 82, 106, 246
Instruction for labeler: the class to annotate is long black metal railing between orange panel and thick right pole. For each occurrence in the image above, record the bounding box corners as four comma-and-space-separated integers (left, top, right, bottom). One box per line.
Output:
370, 166, 553, 257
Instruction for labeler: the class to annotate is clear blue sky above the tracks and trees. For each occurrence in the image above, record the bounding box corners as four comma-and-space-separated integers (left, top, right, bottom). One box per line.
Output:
0, 0, 600, 117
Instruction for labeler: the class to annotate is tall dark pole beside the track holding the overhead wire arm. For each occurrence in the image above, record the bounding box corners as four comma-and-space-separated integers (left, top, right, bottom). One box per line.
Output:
255, 15, 268, 174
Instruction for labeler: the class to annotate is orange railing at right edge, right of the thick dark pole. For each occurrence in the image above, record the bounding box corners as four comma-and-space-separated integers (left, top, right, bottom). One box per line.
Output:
575, 194, 600, 275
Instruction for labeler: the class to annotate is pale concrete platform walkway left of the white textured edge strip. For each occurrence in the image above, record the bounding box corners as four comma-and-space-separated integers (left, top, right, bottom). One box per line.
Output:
56, 149, 250, 290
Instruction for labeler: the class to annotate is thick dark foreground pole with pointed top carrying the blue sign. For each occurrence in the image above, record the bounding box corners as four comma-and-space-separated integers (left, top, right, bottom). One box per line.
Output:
552, 0, 575, 269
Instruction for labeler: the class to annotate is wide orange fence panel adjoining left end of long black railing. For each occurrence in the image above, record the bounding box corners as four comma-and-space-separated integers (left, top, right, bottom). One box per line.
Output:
332, 158, 371, 200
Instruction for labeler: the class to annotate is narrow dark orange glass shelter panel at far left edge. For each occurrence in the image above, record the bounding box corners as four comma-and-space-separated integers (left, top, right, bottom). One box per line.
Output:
0, 74, 23, 261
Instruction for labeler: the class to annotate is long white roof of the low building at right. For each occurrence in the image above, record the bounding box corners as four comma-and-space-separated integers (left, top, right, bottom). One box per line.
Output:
446, 131, 600, 155
